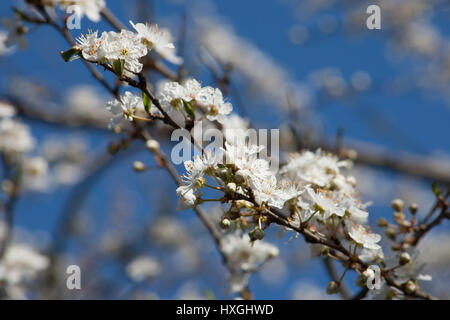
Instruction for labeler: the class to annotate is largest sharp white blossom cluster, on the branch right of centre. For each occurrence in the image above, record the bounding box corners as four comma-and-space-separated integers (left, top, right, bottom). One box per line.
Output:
177, 134, 384, 292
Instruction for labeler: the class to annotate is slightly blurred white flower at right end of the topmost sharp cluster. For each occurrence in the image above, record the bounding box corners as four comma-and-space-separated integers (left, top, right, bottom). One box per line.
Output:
130, 21, 183, 64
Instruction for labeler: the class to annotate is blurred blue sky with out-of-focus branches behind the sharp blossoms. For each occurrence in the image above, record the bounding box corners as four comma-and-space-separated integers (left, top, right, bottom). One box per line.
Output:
0, 0, 450, 299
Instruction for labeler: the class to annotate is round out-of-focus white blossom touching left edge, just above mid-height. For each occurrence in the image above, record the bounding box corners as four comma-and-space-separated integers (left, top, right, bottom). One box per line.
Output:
0, 118, 34, 156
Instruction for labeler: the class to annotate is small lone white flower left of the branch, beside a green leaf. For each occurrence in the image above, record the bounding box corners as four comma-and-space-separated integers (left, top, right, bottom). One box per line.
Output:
106, 91, 144, 129
